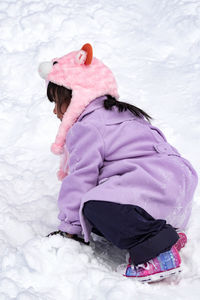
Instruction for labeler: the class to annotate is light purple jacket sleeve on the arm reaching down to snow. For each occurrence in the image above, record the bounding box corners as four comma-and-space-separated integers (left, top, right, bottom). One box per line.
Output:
58, 122, 104, 234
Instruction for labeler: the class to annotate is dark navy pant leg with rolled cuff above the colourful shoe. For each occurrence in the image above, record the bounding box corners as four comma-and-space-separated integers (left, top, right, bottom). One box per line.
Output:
83, 200, 179, 265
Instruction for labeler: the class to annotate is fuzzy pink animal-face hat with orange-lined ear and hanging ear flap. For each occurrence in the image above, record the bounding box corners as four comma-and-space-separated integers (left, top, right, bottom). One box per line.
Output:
38, 44, 119, 179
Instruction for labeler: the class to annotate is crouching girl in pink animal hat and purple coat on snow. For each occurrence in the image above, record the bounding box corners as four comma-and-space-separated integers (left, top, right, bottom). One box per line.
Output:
39, 44, 198, 281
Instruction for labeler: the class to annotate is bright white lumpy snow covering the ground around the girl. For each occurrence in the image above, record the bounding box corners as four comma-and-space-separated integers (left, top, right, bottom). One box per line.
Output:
0, 0, 200, 300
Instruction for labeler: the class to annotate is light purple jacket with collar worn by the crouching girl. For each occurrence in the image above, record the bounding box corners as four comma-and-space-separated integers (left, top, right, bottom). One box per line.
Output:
58, 97, 198, 241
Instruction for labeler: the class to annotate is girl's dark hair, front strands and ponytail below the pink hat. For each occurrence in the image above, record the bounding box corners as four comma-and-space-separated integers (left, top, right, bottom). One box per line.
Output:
47, 81, 153, 123
